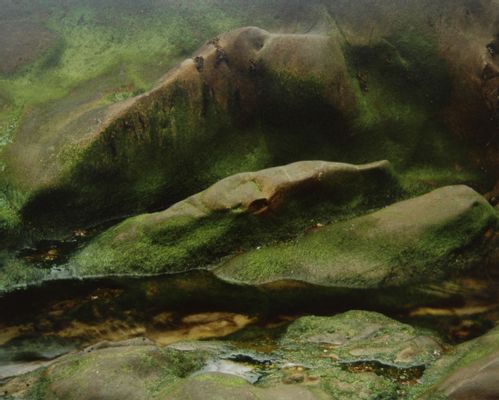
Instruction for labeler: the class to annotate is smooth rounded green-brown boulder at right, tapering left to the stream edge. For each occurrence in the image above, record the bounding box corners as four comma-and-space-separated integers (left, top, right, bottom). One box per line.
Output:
215, 186, 498, 289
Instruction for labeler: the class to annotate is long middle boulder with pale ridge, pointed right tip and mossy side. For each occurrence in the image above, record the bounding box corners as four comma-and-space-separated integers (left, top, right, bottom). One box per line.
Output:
71, 161, 398, 275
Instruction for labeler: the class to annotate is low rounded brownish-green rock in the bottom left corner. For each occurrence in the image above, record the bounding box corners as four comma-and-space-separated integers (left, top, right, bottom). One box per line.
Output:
2, 340, 211, 400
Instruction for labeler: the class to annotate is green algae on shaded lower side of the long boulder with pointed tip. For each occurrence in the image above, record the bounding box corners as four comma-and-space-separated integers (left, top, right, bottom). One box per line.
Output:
72, 161, 397, 275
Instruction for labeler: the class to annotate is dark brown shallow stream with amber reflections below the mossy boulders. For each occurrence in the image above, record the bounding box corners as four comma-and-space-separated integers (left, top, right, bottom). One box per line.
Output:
0, 264, 499, 381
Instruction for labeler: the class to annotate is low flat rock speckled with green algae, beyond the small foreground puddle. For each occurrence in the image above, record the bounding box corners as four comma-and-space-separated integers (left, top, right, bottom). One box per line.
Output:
280, 311, 444, 369
